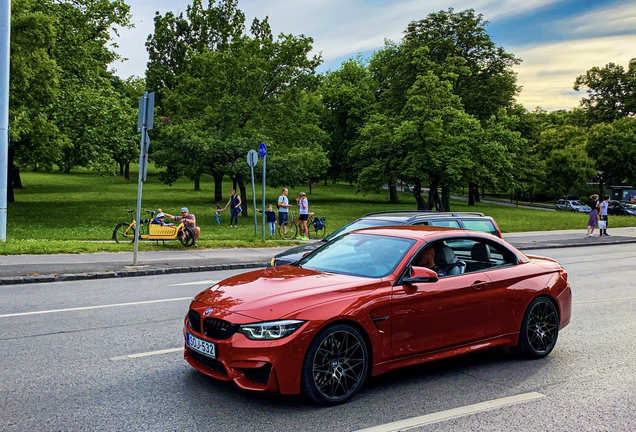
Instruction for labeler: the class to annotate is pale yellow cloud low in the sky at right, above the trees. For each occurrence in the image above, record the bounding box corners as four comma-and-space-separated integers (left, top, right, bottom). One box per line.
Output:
510, 35, 636, 110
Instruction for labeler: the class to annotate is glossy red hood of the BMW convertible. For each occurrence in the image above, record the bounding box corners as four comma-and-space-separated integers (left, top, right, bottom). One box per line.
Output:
194, 265, 380, 321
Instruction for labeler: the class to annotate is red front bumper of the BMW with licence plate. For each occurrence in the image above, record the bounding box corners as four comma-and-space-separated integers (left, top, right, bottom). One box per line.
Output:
183, 316, 313, 394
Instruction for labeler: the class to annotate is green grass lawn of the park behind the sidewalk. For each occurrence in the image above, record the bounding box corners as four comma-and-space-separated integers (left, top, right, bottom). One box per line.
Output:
0, 165, 636, 255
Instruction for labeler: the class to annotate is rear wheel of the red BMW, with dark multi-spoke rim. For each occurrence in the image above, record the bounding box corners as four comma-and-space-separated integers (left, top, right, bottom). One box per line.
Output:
512, 297, 559, 359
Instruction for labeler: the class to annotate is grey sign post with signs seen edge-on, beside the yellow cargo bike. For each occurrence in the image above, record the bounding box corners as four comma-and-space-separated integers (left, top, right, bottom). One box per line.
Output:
133, 92, 155, 266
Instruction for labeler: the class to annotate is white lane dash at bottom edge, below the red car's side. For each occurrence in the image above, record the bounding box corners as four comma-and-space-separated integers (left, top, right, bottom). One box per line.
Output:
357, 392, 545, 432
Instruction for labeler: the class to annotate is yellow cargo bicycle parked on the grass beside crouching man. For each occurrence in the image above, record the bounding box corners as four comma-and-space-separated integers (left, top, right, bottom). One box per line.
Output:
113, 210, 194, 247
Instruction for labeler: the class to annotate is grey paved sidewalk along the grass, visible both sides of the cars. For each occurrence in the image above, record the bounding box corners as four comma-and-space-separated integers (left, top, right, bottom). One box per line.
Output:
0, 227, 636, 285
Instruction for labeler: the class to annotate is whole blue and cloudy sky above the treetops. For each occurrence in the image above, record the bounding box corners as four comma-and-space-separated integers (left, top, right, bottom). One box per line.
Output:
113, 0, 636, 111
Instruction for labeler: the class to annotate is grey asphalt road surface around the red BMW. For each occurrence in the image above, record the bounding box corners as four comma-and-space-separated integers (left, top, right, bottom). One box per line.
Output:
0, 244, 636, 432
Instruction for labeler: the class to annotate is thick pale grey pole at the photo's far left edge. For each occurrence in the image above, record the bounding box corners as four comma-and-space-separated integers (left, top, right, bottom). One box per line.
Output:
0, 0, 11, 242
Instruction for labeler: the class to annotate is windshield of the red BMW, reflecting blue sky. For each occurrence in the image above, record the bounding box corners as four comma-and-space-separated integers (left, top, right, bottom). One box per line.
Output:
296, 233, 415, 278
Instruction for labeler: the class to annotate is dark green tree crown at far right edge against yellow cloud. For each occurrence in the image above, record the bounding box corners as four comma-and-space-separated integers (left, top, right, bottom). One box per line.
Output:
574, 58, 636, 124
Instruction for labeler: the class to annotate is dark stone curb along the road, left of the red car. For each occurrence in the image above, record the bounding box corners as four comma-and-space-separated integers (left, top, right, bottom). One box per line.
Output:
0, 262, 267, 285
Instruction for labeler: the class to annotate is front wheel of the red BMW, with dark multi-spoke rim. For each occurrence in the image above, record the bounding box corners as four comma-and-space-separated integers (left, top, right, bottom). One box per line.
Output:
301, 324, 369, 406
